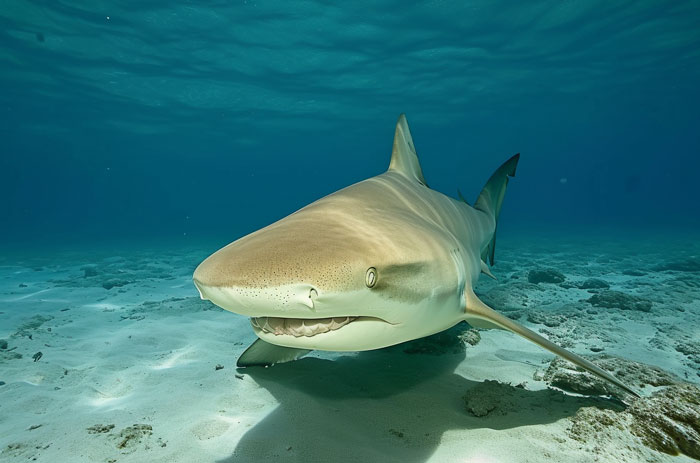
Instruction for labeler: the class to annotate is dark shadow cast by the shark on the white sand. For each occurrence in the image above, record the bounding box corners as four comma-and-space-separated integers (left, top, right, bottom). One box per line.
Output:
219, 328, 616, 463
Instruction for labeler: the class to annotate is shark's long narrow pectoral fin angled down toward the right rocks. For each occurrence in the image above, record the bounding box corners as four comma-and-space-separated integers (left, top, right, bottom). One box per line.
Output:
464, 290, 639, 397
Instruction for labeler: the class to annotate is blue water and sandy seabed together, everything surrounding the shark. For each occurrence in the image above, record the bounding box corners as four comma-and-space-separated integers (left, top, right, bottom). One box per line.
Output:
0, 0, 700, 463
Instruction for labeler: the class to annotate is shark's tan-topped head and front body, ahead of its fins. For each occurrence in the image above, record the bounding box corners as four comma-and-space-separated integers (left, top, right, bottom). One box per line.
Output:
194, 177, 464, 351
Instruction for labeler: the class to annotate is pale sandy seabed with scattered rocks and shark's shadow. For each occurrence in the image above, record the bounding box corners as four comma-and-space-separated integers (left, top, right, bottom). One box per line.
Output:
0, 236, 700, 463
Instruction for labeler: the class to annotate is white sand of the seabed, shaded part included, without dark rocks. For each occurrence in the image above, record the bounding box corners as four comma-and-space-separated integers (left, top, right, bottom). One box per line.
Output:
0, 239, 700, 463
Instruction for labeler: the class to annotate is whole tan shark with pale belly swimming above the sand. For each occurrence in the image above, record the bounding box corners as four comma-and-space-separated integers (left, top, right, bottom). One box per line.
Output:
193, 115, 636, 395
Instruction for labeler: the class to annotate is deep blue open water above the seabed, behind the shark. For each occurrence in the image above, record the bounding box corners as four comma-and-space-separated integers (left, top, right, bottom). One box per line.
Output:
0, 0, 700, 245
